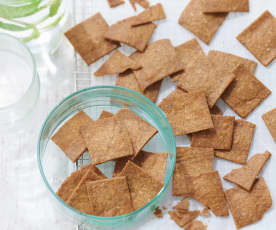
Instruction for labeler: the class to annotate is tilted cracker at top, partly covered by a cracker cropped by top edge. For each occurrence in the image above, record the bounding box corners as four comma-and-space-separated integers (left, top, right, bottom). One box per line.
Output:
178, 0, 227, 44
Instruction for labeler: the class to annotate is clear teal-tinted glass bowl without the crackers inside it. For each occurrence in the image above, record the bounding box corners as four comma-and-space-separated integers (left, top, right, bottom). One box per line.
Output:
37, 86, 176, 230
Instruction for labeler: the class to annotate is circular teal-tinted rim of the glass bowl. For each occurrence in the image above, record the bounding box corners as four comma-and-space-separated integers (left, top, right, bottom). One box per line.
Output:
37, 85, 176, 221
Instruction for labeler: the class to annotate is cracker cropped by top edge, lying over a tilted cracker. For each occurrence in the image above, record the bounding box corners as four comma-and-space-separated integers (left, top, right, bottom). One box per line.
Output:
202, 0, 249, 13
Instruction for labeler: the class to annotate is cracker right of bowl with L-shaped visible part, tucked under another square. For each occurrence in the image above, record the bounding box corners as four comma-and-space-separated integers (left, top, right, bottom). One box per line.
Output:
215, 120, 256, 164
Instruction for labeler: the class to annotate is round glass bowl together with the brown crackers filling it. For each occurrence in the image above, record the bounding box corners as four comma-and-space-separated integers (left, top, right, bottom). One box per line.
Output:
38, 86, 176, 229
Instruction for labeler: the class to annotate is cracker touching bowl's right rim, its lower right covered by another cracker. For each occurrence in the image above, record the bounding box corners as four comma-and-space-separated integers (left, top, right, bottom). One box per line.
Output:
173, 147, 214, 196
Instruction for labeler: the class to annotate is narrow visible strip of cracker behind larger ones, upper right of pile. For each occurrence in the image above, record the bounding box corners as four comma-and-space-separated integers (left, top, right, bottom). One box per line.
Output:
208, 50, 258, 73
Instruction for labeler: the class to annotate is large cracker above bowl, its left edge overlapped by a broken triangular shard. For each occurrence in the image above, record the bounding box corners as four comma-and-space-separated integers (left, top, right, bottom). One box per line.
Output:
132, 39, 183, 91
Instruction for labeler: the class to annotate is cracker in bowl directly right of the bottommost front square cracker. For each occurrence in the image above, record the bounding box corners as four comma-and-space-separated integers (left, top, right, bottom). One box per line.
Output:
119, 161, 163, 210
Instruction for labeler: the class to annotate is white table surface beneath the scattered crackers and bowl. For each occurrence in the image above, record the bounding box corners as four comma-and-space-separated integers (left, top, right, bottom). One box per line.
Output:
0, 0, 276, 230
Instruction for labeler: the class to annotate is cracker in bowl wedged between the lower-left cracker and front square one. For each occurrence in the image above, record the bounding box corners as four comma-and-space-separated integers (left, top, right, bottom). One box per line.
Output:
67, 168, 106, 215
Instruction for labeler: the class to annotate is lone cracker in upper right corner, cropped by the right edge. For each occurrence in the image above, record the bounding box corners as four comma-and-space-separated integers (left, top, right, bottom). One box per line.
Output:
237, 11, 276, 66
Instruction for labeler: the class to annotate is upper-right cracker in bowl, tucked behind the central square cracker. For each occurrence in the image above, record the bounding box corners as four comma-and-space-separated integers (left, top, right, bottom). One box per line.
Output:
115, 109, 158, 158
